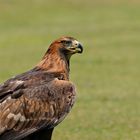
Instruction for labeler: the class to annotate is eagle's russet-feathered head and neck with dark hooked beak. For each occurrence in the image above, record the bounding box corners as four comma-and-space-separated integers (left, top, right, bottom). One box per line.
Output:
37, 37, 83, 73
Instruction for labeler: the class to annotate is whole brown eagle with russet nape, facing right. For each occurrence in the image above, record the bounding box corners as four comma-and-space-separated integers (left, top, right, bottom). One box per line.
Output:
0, 37, 83, 140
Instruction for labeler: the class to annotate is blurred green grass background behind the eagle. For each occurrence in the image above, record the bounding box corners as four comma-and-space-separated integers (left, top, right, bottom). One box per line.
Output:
0, 0, 140, 140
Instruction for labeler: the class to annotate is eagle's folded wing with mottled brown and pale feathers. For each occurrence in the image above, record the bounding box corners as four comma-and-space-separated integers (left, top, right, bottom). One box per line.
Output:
0, 72, 75, 140
